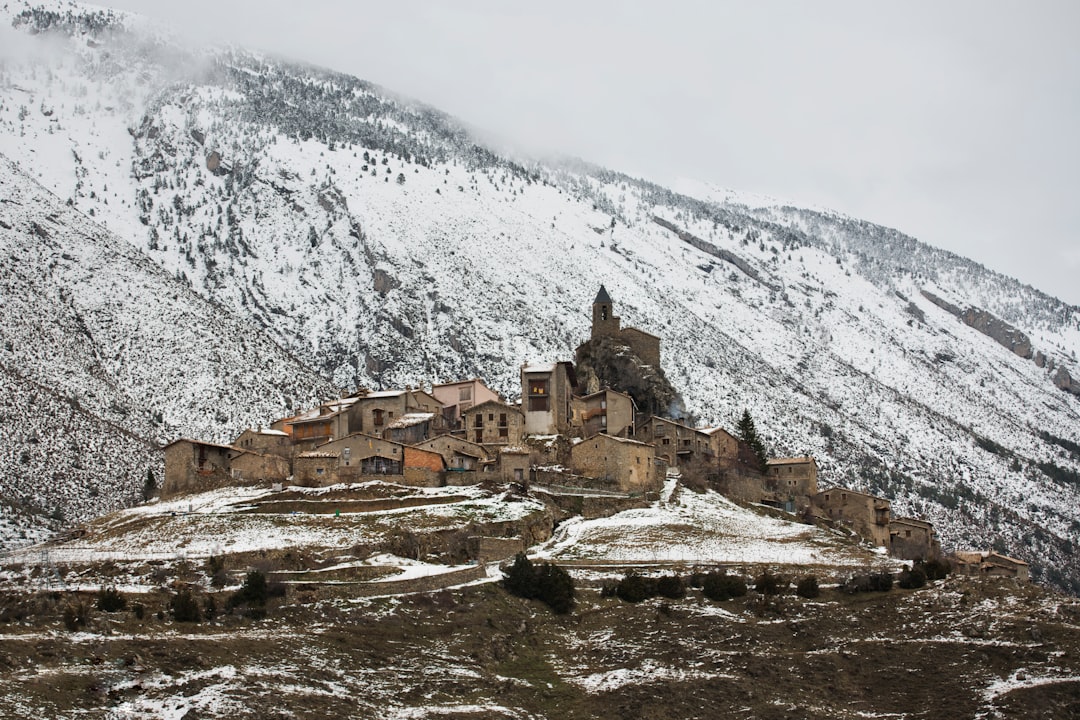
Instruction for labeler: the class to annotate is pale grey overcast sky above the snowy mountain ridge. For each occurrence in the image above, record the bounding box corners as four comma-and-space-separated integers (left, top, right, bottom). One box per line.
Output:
98, 0, 1080, 304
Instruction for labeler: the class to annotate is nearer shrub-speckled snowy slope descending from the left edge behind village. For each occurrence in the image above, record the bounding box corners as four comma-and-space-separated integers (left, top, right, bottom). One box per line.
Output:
0, 157, 329, 546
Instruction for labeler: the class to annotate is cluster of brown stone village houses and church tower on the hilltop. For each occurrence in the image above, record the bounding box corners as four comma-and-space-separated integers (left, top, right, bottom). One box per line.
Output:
161, 287, 939, 560
